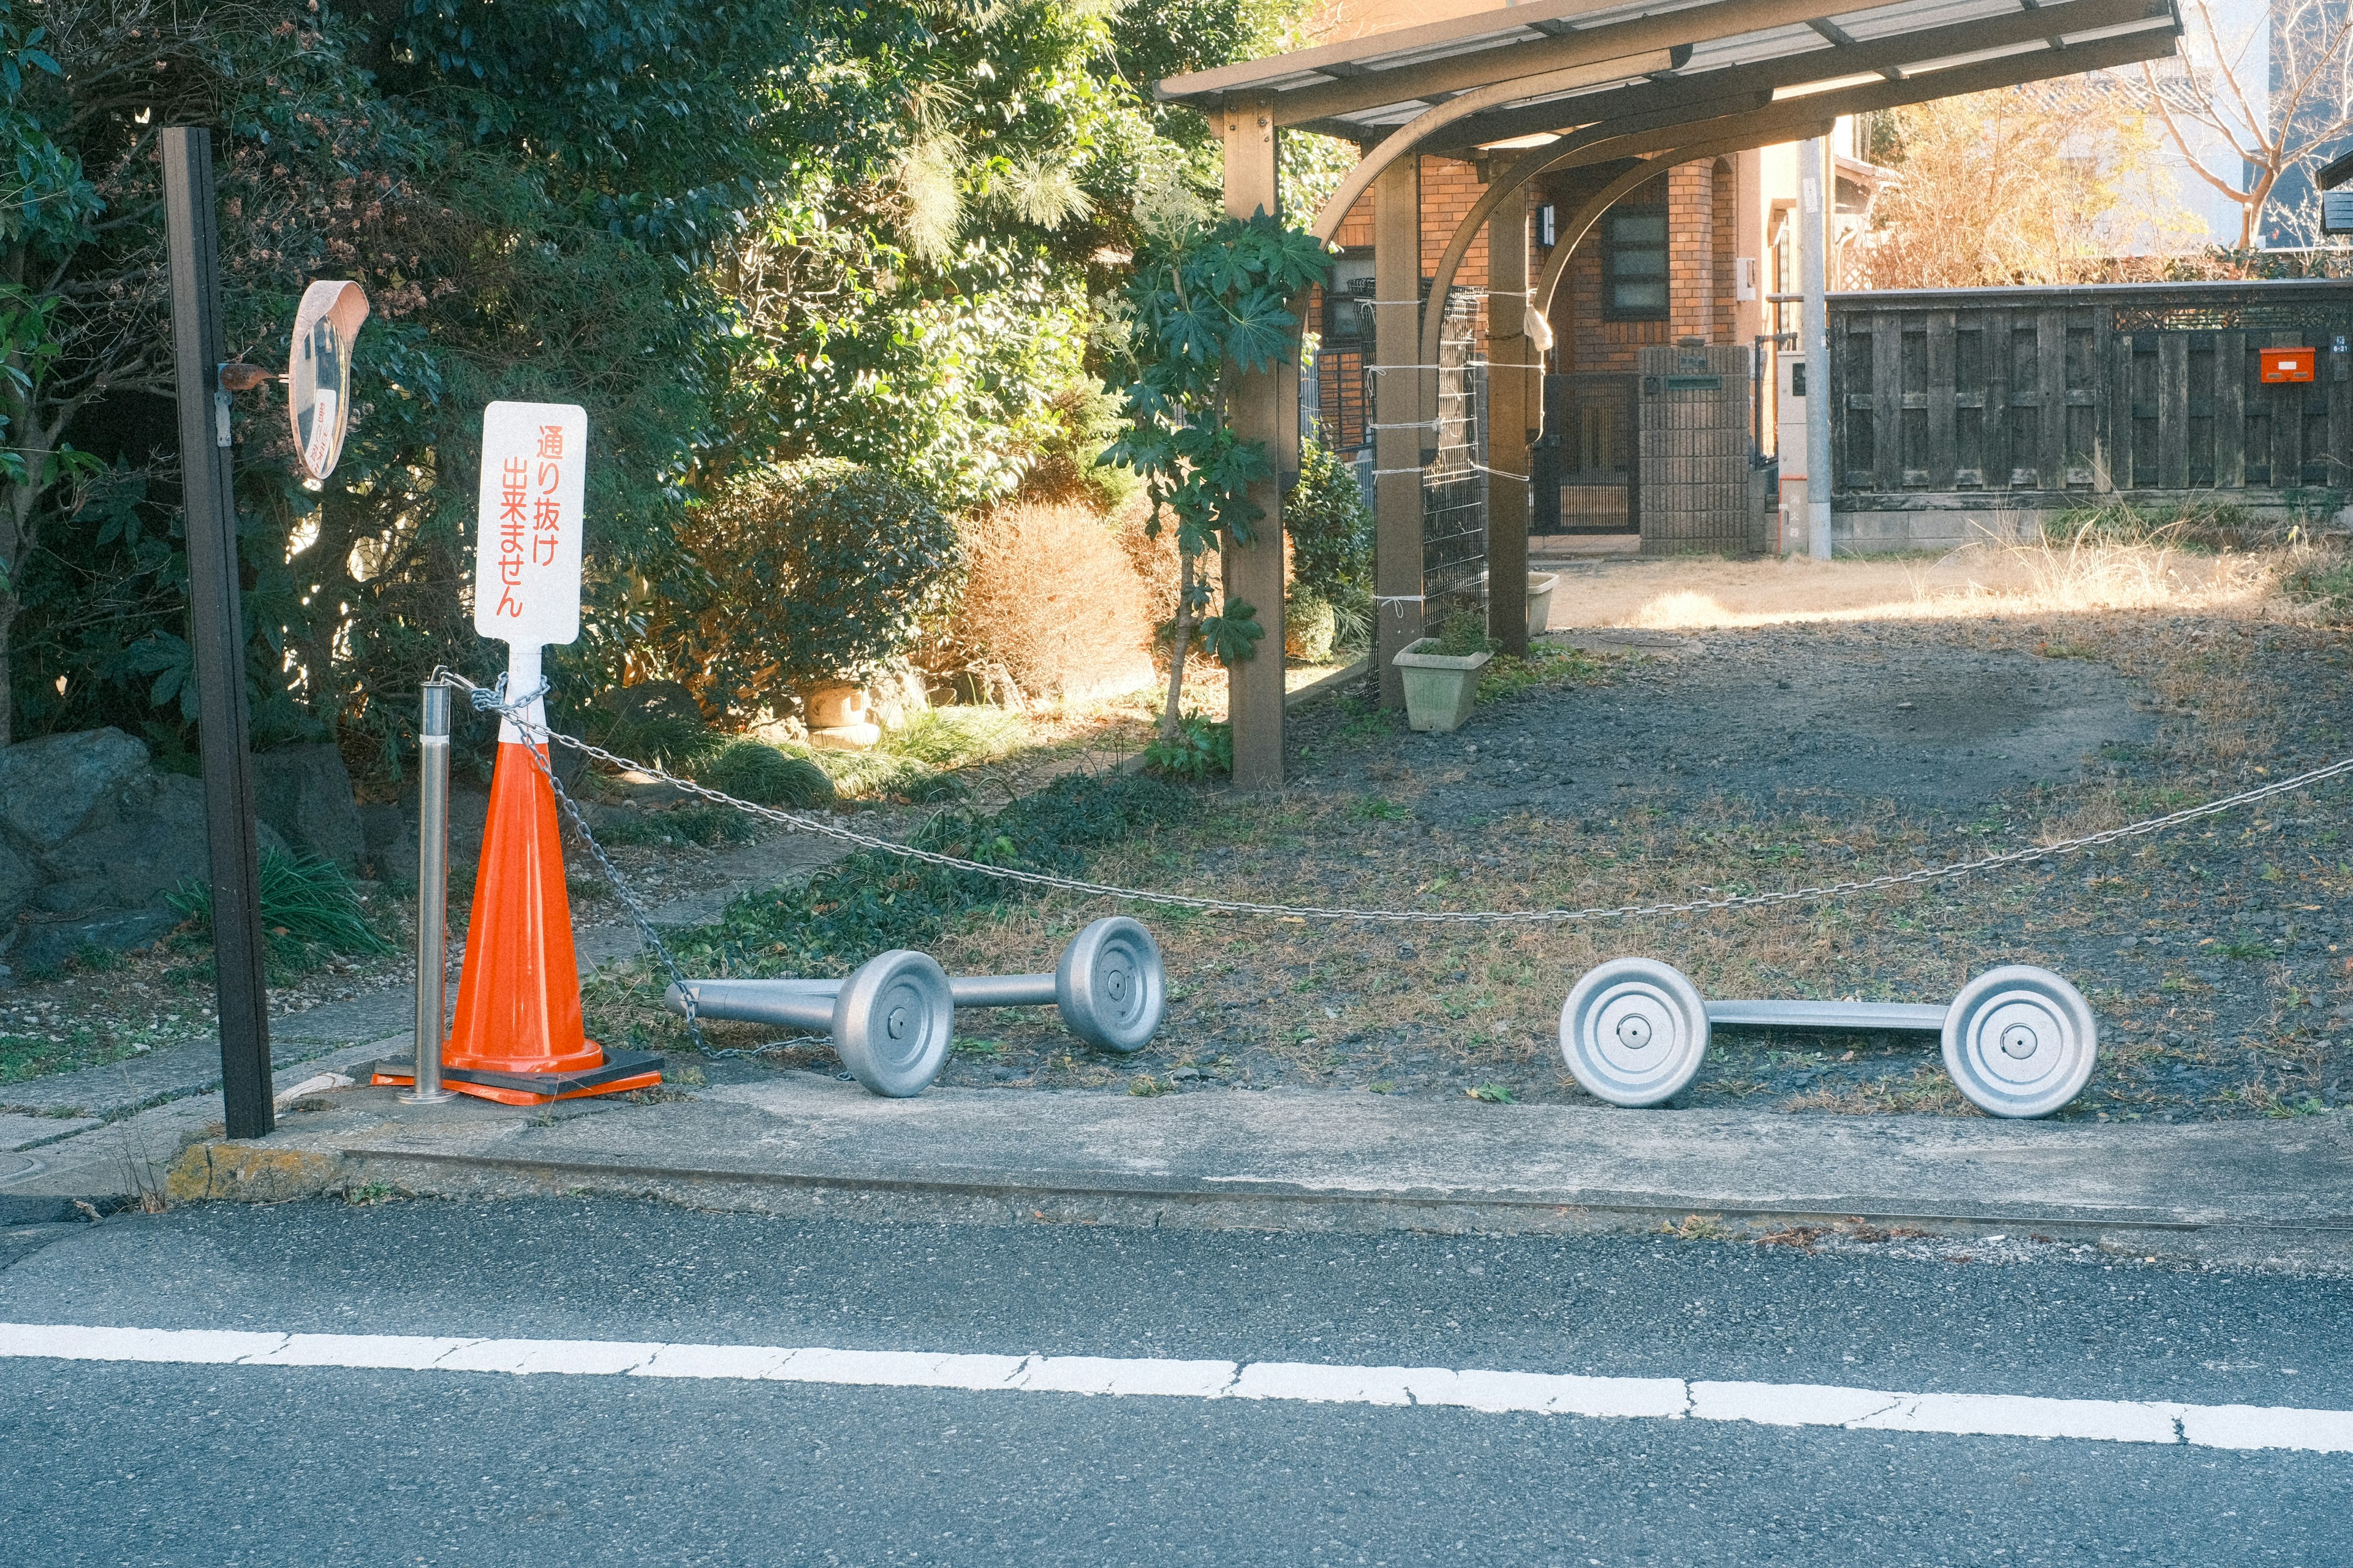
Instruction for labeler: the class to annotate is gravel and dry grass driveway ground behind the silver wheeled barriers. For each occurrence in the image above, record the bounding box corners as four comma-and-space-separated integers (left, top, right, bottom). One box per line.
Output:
715, 600, 2353, 1121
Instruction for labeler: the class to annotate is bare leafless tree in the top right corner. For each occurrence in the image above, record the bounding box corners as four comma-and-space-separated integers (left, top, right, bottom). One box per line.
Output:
2141, 0, 2353, 249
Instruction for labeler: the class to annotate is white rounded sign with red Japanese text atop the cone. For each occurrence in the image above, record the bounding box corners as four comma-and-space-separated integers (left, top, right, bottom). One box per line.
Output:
473, 403, 588, 648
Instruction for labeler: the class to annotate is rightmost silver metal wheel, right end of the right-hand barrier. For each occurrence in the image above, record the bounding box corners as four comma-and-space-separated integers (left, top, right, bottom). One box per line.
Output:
1944, 963, 2099, 1116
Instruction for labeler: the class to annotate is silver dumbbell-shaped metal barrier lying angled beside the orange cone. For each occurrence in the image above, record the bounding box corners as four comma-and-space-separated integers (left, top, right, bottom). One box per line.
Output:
664, 916, 1167, 1095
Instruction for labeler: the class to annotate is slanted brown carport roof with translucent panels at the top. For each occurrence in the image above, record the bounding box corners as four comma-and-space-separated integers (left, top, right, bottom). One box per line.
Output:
1155, 0, 2181, 153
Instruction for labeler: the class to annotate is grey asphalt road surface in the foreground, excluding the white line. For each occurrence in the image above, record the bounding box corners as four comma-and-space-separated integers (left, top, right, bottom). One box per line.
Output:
0, 1201, 2353, 1568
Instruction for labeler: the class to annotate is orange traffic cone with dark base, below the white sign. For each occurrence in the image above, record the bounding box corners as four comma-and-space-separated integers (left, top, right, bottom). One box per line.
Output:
376, 739, 661, 1104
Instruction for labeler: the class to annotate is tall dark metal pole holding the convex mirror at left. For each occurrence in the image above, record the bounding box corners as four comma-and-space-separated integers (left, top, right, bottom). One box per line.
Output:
162, 125, 275, 1137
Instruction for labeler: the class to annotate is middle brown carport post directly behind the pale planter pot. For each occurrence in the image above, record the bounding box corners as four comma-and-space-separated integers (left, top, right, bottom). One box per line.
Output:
1372, 157, 1435, 709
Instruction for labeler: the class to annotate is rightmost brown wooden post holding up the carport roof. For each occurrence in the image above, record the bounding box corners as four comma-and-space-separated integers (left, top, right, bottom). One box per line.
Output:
1487, 168, 1544, 659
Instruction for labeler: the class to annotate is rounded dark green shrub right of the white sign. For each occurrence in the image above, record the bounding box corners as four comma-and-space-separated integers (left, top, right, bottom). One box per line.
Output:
647, 459, 963, 713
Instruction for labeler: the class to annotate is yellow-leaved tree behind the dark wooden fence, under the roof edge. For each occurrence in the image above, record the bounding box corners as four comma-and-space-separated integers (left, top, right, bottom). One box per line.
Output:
1861, 78, 2188, 290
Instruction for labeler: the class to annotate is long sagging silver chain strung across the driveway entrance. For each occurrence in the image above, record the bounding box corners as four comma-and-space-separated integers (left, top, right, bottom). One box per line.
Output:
435, 671, 2353, 925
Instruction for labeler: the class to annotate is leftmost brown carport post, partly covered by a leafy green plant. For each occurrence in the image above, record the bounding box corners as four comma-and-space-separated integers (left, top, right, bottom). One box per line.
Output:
1219, 104, 1299, 789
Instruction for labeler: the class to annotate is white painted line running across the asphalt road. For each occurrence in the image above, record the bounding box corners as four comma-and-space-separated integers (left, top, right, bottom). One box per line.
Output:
0, 1323, 2353, 1453
